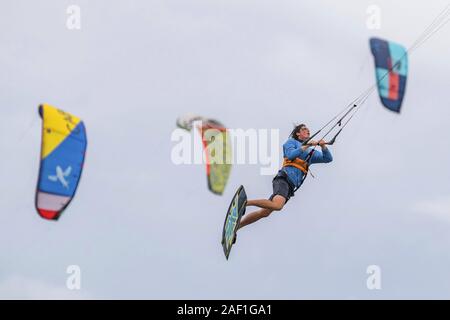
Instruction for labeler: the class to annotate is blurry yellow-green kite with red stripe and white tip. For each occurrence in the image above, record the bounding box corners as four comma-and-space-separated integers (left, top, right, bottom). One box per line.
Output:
177, 115, 231, 195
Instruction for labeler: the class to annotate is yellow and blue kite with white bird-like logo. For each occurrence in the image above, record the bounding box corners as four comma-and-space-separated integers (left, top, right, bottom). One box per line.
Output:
36, 104, 87, 220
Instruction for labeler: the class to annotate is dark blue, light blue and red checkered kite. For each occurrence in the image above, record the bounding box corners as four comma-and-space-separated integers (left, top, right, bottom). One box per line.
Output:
370, 38, 408, 113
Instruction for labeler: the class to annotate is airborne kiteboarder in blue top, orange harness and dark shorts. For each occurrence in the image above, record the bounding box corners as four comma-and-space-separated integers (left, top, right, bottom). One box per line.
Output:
238, 124, 333, 229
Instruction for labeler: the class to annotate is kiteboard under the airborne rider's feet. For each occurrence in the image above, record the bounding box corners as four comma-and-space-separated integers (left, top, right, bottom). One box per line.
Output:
222, 186, 247, 260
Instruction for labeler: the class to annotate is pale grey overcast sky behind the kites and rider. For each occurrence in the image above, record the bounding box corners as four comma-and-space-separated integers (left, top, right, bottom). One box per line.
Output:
0, 0, 450, 299
